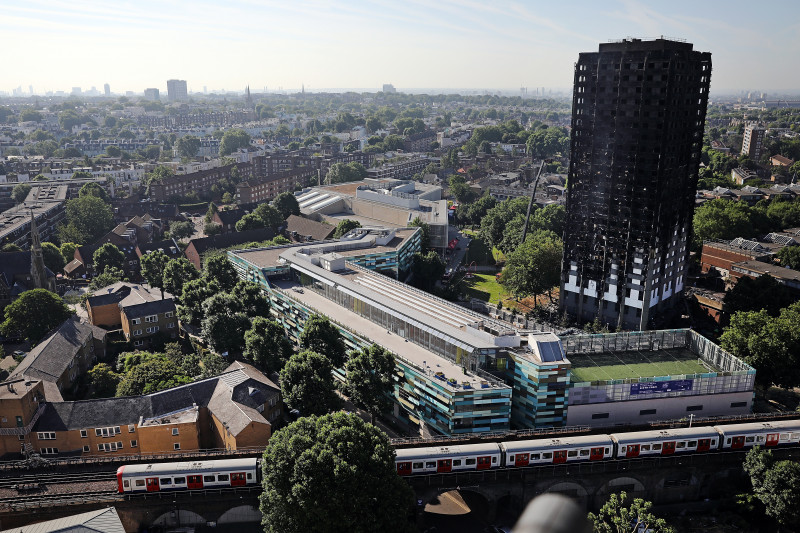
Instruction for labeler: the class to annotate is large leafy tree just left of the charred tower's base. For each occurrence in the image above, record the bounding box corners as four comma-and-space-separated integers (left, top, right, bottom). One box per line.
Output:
502, 230, 563, 299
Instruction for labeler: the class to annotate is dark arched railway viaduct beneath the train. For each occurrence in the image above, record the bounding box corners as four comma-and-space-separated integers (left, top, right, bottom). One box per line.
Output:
0, 448, 800, 531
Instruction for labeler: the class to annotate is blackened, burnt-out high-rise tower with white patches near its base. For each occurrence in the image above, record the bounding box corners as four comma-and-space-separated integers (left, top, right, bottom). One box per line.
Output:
560, 39, 711, 329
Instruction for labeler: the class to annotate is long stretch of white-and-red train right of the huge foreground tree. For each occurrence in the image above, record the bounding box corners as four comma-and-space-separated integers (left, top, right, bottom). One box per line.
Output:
395, 420, 800, 476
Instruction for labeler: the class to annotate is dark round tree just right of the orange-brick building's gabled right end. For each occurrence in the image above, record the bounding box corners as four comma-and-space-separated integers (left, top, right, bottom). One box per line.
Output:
280, 350, 341, 416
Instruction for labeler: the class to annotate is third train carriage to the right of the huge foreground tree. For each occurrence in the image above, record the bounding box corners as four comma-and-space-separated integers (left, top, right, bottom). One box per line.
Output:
611, 427, 720, 459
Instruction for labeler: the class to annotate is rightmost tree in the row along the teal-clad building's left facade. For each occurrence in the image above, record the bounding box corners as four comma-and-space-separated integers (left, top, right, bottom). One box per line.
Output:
344, 344, 394, 423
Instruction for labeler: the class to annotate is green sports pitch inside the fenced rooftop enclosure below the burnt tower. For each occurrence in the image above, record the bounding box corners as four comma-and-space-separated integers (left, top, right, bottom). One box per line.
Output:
570, 350, 710, 382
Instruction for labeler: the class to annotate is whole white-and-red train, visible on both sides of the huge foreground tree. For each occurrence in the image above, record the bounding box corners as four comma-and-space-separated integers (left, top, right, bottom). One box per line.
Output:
117, 420, 800, 493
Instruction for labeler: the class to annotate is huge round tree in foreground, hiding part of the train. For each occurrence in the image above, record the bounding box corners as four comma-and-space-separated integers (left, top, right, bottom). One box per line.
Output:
260, 413, 413, 533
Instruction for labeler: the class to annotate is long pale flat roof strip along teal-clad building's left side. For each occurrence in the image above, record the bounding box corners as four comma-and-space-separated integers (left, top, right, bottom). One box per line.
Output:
272, 280, 492, 389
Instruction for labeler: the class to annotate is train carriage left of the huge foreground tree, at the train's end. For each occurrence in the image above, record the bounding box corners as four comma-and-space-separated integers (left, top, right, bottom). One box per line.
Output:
117, 458, 258, 493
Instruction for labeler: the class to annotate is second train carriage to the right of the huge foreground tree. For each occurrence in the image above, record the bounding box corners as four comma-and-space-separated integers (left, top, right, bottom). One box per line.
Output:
500, 435, 614, 467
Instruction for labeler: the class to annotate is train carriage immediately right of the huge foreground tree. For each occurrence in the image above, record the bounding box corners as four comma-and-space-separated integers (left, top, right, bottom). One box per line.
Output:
395, 442, 500, 476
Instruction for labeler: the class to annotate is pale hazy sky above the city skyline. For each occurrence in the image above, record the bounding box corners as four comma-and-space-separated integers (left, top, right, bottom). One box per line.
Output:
6, 0, 800, 94
